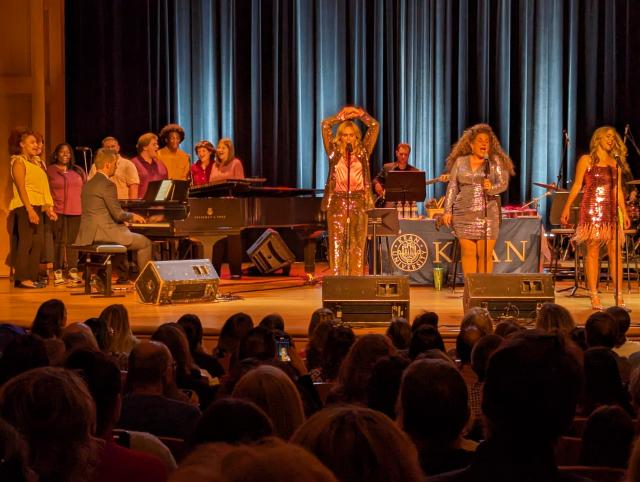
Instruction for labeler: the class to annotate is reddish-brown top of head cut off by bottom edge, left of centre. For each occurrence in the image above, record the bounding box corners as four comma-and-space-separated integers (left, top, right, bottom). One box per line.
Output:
171, 437, 337, 482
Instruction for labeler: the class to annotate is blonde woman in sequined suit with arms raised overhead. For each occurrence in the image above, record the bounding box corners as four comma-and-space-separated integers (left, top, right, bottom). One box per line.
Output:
322, 106, 380, 276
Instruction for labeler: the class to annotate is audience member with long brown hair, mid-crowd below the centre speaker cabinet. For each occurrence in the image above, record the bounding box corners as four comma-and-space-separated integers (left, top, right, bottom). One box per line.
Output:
327, 334, 395, 405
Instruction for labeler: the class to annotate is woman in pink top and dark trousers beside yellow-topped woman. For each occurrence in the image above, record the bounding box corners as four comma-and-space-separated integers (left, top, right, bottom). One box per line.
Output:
47, 143, 87, 269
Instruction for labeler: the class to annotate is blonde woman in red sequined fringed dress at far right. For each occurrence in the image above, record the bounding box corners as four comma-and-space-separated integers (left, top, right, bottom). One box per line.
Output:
560, 126, 631, 310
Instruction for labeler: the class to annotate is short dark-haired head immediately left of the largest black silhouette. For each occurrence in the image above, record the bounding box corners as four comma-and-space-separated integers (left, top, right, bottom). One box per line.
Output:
399, 360, 469, 449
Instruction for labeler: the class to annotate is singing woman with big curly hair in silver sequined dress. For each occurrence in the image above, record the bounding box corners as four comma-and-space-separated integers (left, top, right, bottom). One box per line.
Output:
442, 124, 515, 275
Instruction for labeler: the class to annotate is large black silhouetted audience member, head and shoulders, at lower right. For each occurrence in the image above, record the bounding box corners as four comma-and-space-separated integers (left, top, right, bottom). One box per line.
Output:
428, 330, 581, 482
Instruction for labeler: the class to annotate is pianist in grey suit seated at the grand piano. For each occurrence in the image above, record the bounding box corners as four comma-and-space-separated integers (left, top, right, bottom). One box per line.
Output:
75, 149, 151, 278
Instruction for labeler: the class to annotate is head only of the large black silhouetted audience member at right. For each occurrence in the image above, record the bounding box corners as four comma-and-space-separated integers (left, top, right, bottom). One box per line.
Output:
482, 330, 582, 445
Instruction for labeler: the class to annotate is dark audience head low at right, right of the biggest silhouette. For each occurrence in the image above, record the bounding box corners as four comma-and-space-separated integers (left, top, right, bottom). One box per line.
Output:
580, 406, 635, 469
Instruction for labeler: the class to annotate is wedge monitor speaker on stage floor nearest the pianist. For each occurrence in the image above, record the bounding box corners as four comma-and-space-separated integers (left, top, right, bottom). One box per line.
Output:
136, 259, 220, 305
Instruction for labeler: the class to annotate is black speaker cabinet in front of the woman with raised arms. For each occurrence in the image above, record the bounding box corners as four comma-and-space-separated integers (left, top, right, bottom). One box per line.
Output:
322, 276, 409, 326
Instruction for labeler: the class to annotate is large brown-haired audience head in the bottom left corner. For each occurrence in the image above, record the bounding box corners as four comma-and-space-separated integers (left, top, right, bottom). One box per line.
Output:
0, 367, 97, 480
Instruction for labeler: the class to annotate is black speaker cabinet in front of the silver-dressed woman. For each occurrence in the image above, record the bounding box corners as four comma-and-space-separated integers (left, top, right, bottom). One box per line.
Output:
463, 273, 555, 322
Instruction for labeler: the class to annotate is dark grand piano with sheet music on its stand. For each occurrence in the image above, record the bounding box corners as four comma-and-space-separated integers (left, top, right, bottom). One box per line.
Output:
121, 180, 326, 274
